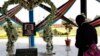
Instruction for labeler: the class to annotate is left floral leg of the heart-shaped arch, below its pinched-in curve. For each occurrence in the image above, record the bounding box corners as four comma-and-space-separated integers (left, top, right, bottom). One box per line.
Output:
4, 18, 18, 56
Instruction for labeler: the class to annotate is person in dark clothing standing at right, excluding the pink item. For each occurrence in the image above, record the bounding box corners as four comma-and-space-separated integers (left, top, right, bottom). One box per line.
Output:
75, 15, 98, 56
